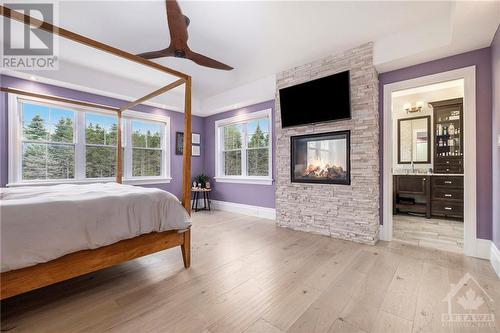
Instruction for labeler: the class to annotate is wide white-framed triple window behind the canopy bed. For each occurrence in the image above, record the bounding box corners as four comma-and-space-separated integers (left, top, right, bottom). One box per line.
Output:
9, 95, 170, 185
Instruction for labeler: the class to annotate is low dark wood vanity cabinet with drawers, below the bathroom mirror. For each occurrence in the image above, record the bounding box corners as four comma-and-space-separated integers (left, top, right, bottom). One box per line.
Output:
393, 175, 464, 219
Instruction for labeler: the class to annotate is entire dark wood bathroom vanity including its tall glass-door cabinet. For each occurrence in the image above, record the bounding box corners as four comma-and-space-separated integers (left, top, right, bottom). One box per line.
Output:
393, 98, 464, 219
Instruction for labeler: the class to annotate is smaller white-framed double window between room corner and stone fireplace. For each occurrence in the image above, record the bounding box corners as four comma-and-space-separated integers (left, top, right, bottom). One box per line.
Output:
215, 110, 272, 185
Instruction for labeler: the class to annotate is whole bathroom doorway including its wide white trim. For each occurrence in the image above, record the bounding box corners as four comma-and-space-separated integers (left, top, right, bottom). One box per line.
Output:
380, 66, 478, 256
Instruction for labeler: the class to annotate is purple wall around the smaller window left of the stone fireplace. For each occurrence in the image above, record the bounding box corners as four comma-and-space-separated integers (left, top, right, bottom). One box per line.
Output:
204, 100, 276, 208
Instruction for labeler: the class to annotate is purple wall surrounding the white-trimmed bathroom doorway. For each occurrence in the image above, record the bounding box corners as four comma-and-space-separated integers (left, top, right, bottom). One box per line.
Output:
379, 47, 498, 239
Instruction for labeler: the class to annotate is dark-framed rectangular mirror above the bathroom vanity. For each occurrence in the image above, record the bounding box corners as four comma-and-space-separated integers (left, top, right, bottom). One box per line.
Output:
398, 116, 431, 164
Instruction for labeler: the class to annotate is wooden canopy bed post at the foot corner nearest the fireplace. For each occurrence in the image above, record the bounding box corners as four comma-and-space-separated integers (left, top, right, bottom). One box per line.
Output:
181, 76, 191, 268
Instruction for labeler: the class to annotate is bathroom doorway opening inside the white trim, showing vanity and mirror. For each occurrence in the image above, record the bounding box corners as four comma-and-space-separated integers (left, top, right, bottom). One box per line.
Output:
392, 79, 464, 253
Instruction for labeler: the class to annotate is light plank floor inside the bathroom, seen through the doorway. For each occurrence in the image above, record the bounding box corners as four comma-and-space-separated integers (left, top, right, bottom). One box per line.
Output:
393, 214, 464, 253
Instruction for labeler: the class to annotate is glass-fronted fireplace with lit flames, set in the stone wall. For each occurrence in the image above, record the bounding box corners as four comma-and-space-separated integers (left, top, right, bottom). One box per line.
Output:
291, 131, 351, 185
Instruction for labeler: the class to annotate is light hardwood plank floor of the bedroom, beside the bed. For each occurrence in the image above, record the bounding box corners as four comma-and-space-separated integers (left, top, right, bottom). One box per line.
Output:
1, 211, 500, 333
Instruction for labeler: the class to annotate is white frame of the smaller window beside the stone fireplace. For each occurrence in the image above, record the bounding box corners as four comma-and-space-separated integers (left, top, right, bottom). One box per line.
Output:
214, 109, 273, 185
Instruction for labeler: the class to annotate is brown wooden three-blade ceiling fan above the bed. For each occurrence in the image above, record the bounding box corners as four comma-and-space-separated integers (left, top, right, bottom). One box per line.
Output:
138, 0, 233, 71
